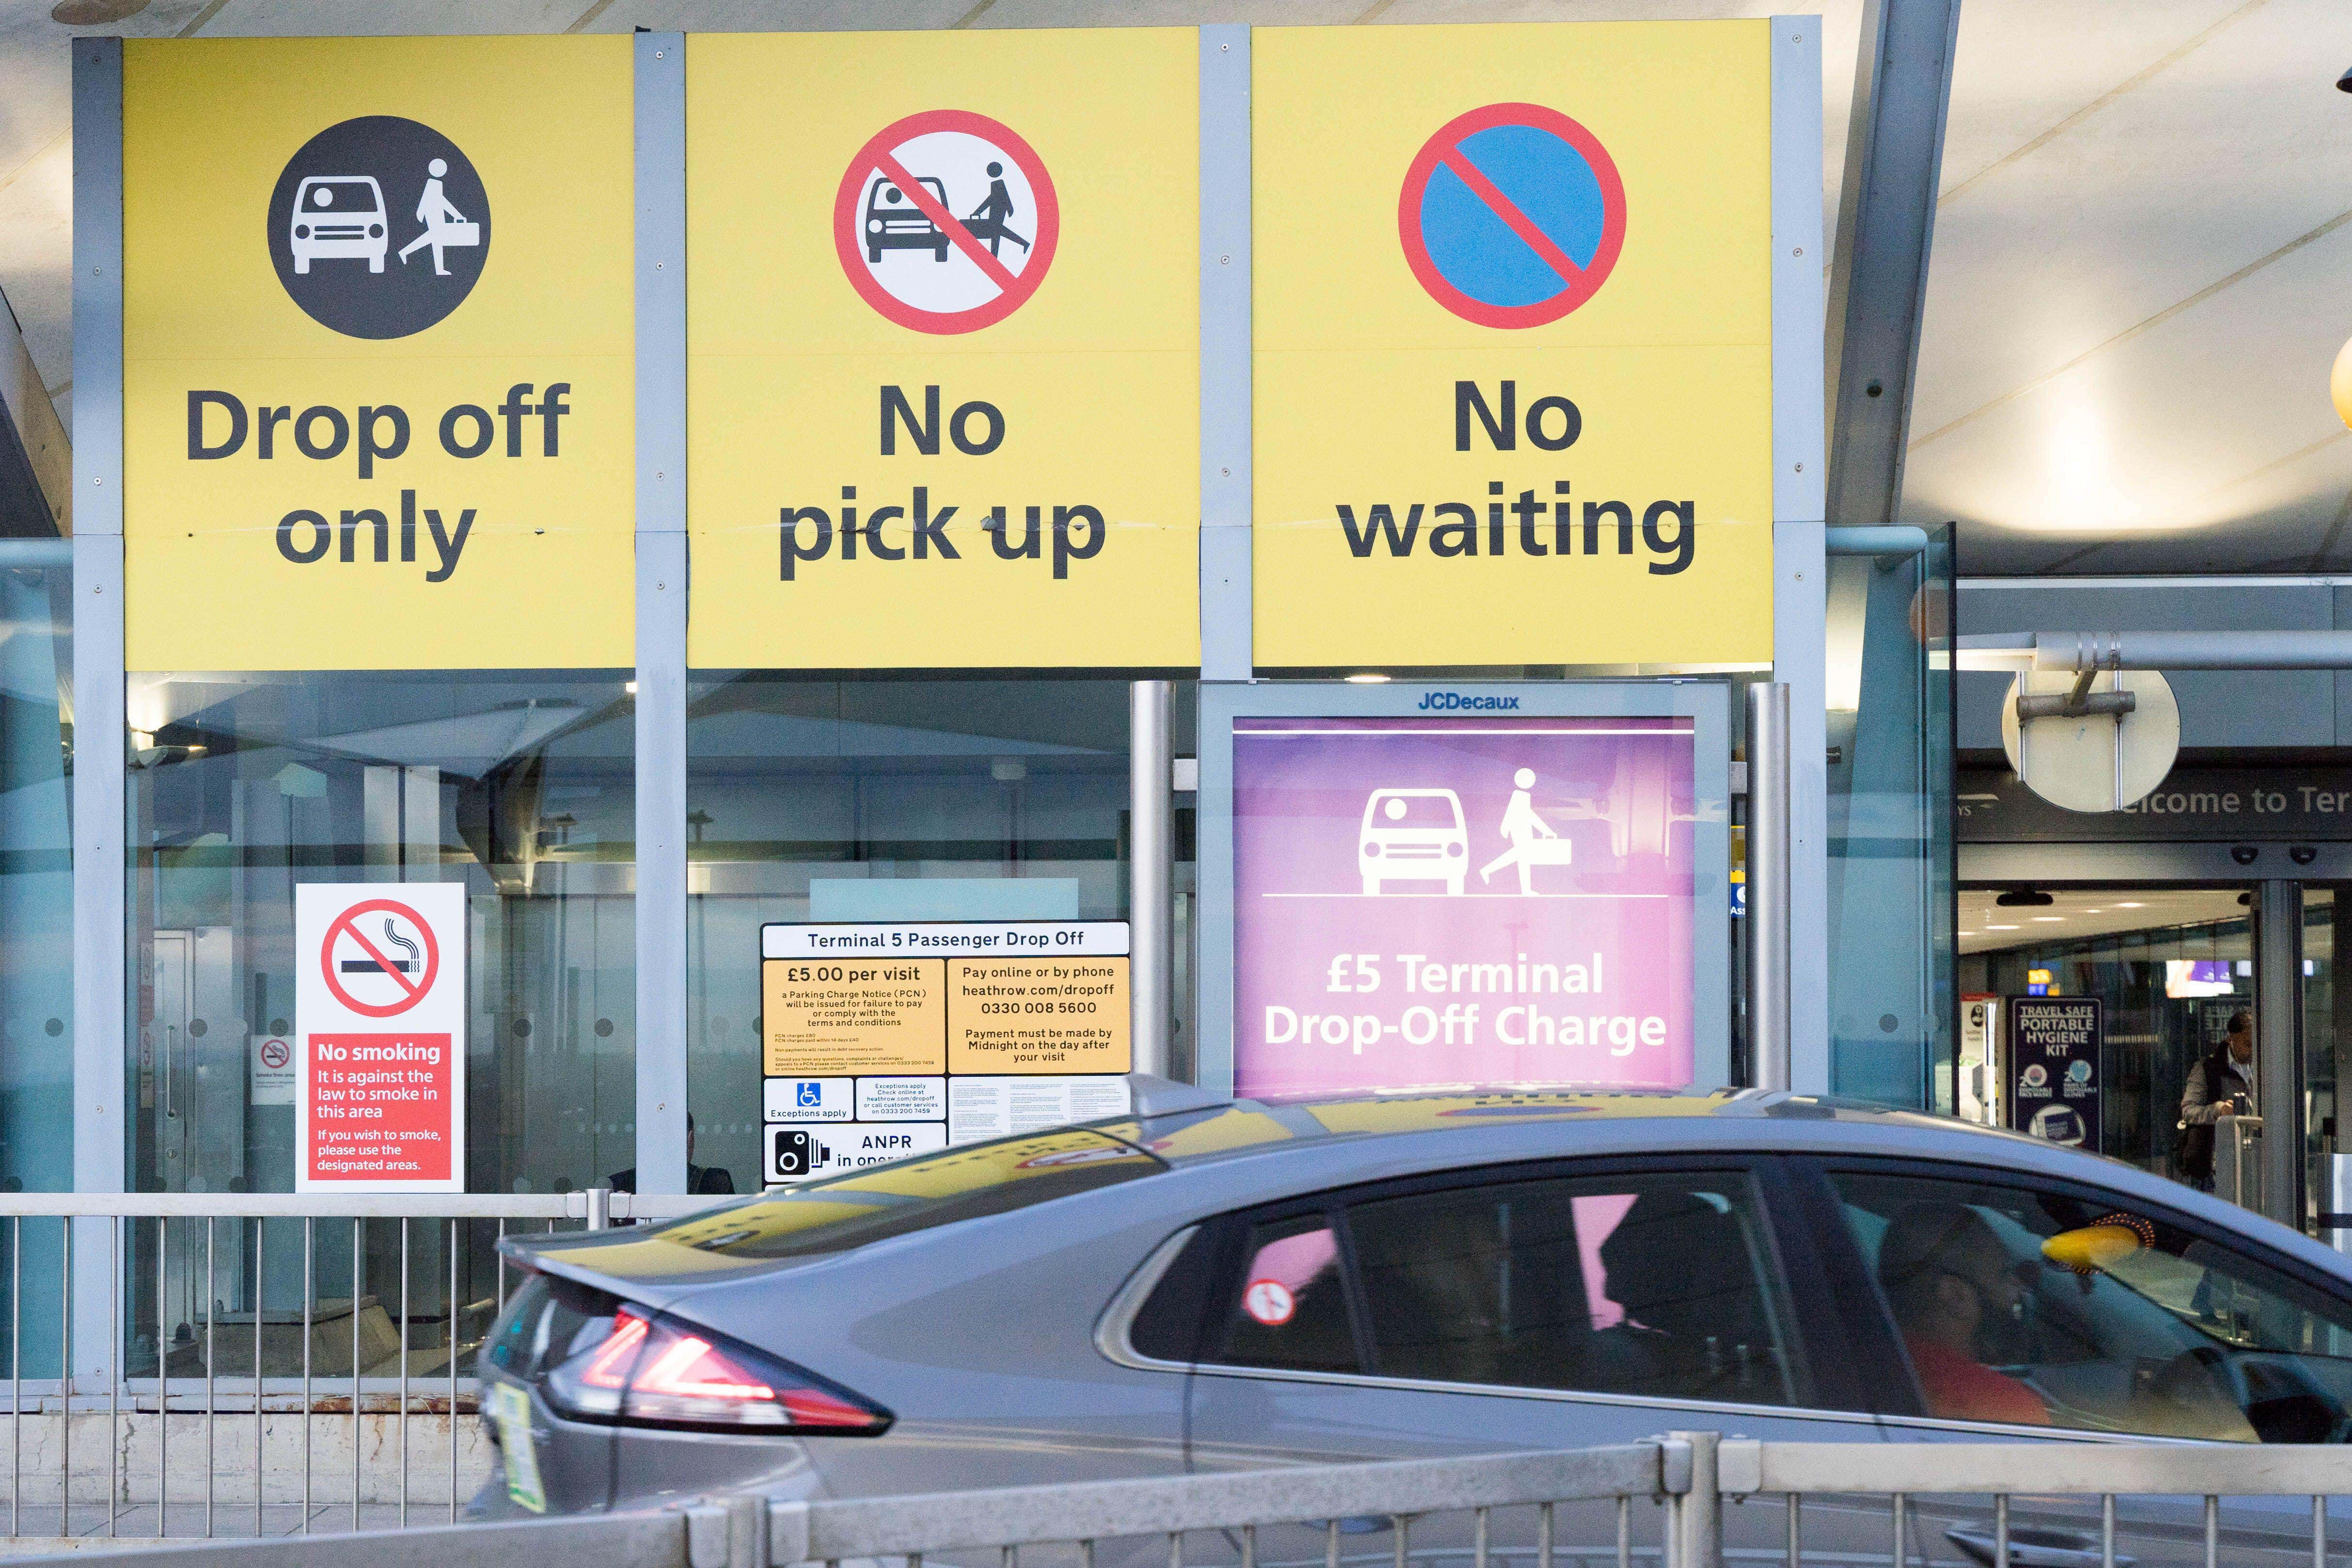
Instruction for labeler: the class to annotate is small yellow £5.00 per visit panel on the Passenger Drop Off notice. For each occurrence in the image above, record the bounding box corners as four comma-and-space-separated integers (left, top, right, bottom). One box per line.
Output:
760, 959, 948, 1077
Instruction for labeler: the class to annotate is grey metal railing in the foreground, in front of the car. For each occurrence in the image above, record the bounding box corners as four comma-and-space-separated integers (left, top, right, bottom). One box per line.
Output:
32, 1432, 2352, 1568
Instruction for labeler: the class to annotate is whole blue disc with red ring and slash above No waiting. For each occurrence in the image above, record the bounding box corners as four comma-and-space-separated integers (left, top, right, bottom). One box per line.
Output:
1397, 103, 1625, 327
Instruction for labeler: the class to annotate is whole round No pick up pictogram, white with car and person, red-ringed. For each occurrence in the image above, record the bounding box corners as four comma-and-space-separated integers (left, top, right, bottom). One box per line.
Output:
832, 108, 1061, 334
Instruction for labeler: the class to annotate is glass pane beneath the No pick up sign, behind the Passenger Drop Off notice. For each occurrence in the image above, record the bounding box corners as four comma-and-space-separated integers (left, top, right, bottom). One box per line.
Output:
687, 670, 1167, 1192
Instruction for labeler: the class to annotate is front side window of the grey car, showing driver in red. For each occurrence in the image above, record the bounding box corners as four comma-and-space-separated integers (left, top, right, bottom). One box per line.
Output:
1830, 1171, 2352, 1443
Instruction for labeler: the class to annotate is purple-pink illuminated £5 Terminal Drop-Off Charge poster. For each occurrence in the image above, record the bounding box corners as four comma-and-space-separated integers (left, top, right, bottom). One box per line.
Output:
1232, 717, 1696, 1095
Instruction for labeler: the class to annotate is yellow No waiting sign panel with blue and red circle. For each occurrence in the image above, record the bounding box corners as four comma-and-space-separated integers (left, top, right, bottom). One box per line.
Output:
1251, 21, 1771, 668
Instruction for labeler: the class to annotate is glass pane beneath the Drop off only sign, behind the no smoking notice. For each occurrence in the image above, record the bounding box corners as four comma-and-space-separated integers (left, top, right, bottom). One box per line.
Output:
127, 670, 638, 1192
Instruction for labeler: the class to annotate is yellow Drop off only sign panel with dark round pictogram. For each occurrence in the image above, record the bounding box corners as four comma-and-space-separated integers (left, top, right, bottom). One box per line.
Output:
122, 38, 635, 670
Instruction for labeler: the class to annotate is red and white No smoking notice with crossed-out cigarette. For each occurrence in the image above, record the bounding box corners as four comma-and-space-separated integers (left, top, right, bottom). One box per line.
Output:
294, 881, 465, 1192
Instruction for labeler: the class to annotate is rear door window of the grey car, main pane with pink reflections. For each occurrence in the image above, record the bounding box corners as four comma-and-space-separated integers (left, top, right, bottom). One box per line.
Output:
1348, 1171, 1808, 1406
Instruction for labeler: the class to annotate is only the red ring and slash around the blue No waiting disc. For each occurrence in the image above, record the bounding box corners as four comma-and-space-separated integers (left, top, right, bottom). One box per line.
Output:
1397, 103, 1625, 327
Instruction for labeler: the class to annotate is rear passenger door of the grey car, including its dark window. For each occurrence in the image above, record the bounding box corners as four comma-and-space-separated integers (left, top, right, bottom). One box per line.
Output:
1148, 1156, 1884, 1561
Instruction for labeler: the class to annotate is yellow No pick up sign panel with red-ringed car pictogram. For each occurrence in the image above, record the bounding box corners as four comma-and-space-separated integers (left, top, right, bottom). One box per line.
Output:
687, 28, 1200, 668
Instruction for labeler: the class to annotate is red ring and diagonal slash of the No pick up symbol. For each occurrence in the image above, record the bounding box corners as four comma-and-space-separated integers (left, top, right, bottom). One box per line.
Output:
832, 108, 1061, 334
